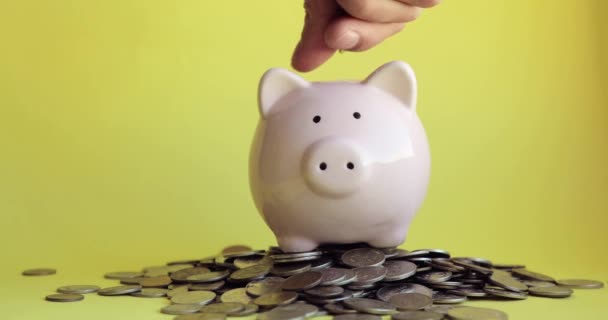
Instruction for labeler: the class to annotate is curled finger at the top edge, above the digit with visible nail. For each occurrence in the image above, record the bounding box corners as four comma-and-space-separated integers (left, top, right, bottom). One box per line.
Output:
337, 0, 422, 23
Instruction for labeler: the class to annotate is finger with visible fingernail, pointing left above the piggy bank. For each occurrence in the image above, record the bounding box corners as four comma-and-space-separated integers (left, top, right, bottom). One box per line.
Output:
325, 17, 405, 51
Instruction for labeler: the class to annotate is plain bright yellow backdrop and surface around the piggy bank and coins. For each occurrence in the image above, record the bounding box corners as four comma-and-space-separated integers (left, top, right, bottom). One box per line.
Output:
0, 0, 608, 319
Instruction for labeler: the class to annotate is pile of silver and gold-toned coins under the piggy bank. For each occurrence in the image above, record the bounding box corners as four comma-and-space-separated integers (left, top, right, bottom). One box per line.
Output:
24, 244, 603, 320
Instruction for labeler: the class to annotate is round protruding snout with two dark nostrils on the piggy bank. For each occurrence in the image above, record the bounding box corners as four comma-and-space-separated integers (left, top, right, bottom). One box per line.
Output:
302, 138, 370, 198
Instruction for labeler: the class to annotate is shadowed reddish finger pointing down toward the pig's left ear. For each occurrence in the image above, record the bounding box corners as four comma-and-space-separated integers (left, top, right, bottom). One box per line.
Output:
291, 0, 338, 72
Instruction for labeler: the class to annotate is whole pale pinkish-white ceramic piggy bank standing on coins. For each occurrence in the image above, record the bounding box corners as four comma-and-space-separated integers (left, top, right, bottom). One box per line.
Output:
249, 61, 430, 252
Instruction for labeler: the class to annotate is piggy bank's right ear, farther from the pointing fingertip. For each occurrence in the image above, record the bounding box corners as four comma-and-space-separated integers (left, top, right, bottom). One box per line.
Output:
363, 61, 417, 111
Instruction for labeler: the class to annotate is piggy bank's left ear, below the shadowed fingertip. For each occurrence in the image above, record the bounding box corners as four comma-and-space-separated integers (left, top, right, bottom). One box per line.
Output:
258, 68, 310, 118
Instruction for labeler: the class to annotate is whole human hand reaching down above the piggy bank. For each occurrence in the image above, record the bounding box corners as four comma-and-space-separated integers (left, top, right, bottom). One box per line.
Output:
292, 0, 441, 72
